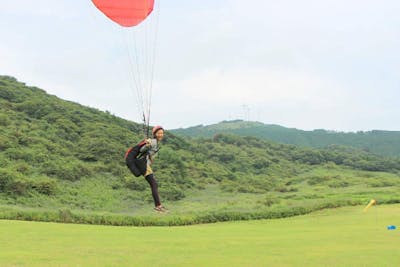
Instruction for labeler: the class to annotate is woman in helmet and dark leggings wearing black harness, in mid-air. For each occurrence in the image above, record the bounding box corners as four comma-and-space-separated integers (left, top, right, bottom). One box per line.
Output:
125, 126, 167, 212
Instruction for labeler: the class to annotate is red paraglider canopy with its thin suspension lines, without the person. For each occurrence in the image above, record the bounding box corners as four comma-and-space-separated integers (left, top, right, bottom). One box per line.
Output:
92, 0, 160, 138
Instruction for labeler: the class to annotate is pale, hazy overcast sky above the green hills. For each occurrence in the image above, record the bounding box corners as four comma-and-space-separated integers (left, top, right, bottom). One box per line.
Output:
0, 0, 400, 131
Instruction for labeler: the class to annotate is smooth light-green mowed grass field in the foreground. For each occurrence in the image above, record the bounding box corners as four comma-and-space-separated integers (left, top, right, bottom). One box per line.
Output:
0, 205, 400, 266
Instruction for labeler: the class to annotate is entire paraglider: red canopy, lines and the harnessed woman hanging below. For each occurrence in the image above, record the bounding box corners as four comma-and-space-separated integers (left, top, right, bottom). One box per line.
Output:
92, 0, 167, 212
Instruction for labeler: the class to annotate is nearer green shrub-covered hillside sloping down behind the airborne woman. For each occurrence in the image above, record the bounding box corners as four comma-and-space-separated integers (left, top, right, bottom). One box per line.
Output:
0, 76, 400, 225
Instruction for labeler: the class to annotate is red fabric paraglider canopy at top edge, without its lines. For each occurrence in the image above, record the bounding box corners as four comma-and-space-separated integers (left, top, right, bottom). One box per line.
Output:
92, 0, 154, 27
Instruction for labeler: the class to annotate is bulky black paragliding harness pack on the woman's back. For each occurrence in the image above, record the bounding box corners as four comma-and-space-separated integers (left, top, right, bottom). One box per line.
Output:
125, 140, 147, 177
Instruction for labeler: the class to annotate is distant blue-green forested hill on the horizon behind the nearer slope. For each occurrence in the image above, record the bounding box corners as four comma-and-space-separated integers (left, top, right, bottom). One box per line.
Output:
172, 120, 400, 157
